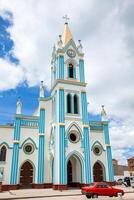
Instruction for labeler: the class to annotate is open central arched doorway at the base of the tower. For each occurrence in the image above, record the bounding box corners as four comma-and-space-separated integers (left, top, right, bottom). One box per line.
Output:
67, 155, 82, 187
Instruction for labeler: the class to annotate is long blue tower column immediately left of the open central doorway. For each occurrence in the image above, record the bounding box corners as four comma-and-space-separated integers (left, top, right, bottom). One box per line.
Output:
58, 89, 67, 184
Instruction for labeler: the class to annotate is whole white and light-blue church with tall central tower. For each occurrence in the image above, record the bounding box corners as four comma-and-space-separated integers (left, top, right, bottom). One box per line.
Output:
0, 21, 114, 190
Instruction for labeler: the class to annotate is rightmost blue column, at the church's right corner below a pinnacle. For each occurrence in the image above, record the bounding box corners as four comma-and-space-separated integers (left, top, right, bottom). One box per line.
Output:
103, 122, 114, 181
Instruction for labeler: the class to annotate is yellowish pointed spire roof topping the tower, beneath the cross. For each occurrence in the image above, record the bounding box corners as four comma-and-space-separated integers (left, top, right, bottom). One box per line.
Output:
62, 22, 73, 46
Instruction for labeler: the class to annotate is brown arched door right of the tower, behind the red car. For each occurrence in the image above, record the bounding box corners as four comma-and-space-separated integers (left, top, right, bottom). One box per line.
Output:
93, 162, 105, 182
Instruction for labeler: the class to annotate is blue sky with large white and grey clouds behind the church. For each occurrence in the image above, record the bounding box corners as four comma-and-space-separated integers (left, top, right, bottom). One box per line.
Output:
0, 0, 134, 164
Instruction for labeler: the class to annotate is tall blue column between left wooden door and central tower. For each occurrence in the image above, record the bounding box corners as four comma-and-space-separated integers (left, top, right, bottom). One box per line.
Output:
37, 108, 45, 184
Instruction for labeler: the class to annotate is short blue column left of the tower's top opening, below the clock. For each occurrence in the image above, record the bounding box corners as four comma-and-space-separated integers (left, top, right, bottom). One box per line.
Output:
57, 55, 64, 79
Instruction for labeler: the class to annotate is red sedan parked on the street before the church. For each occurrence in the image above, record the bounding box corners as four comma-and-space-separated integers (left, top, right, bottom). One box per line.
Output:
81, 182, 124, 199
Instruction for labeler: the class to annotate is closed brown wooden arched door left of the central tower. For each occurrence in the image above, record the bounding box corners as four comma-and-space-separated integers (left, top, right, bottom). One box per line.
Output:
20, 161, 33, 188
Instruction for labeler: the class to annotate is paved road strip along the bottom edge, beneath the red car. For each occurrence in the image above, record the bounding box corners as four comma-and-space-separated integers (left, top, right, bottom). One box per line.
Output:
12, 193, 134, 200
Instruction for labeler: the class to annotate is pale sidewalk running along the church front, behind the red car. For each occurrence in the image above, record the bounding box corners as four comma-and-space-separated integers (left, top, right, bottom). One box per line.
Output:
0, 186, 134, 200
